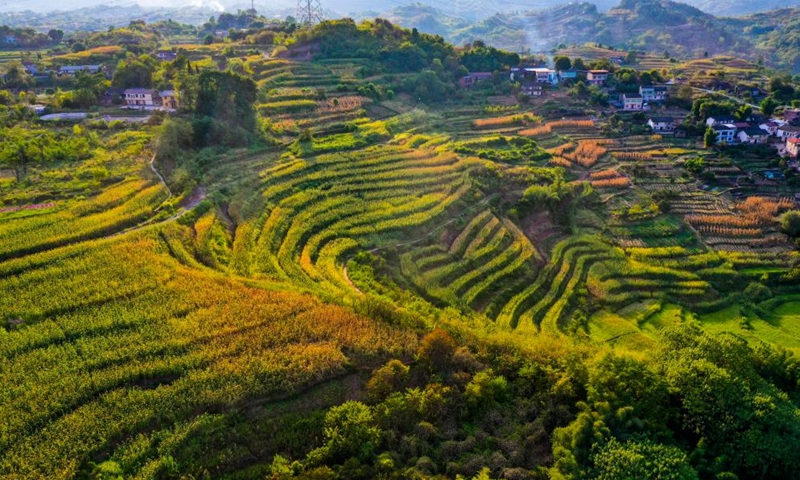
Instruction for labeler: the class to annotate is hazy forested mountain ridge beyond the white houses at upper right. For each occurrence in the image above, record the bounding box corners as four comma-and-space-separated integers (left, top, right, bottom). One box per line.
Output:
382, 0, 800, 72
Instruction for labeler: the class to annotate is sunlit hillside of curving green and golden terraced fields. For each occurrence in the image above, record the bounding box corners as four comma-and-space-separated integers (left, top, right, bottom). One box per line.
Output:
0, 15, 800, 480
